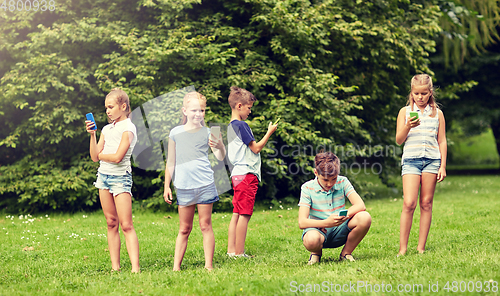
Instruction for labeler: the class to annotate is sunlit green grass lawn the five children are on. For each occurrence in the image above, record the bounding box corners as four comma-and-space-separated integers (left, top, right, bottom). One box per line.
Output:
0, 176, 500, 295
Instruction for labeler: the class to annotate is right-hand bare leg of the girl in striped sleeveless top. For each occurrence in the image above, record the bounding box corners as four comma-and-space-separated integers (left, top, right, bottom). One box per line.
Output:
417, 173, 437, 253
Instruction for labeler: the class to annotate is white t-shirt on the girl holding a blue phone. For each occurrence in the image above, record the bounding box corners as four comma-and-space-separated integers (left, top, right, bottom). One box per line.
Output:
98, 118, 137, 176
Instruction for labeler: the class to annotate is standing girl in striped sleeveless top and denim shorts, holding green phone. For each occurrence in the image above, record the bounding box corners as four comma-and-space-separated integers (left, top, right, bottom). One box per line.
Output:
396, 74, 447, 256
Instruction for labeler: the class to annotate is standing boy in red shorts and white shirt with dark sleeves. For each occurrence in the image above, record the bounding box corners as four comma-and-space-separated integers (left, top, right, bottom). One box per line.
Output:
227, 86, 278, 257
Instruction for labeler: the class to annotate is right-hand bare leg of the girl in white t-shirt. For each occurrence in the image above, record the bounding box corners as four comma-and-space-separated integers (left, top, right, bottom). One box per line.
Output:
115, 193, 141, 272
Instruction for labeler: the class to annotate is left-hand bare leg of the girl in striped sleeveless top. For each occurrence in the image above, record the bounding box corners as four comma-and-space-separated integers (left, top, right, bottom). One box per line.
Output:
398, 174, 421, 255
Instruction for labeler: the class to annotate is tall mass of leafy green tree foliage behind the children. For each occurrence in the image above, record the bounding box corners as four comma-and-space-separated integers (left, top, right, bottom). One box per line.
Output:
0, 0, 476, 213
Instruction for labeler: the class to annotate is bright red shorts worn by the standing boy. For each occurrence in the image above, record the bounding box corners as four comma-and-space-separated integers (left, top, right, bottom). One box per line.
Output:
231, 174, 259, 216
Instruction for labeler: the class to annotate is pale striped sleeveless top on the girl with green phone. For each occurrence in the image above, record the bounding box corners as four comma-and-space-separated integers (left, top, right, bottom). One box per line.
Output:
401, 105, 441, 161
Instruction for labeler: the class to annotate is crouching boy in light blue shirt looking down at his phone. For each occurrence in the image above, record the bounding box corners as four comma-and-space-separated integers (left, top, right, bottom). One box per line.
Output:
299, 152, 372, 265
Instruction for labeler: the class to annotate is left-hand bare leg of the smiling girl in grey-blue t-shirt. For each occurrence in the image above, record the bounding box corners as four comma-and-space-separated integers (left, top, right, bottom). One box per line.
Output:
173, 205, 196, 271
